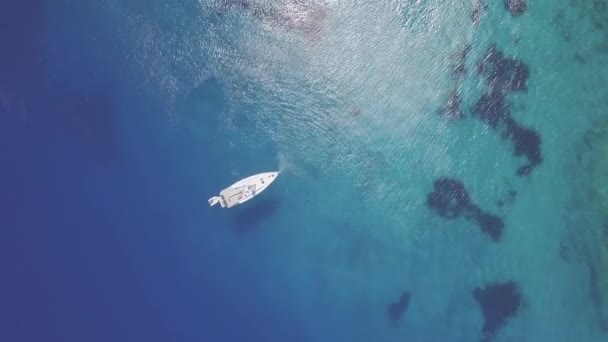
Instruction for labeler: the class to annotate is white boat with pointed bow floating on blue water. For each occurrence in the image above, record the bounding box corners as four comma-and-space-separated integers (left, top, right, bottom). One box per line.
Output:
208, 171, 280, 208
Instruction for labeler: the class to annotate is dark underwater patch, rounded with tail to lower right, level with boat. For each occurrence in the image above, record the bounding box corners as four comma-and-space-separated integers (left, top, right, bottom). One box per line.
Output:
426, 177, 504, 241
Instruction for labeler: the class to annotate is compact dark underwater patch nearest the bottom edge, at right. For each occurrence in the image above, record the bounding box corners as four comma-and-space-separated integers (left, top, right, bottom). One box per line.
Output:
473, 281, 521, 341
